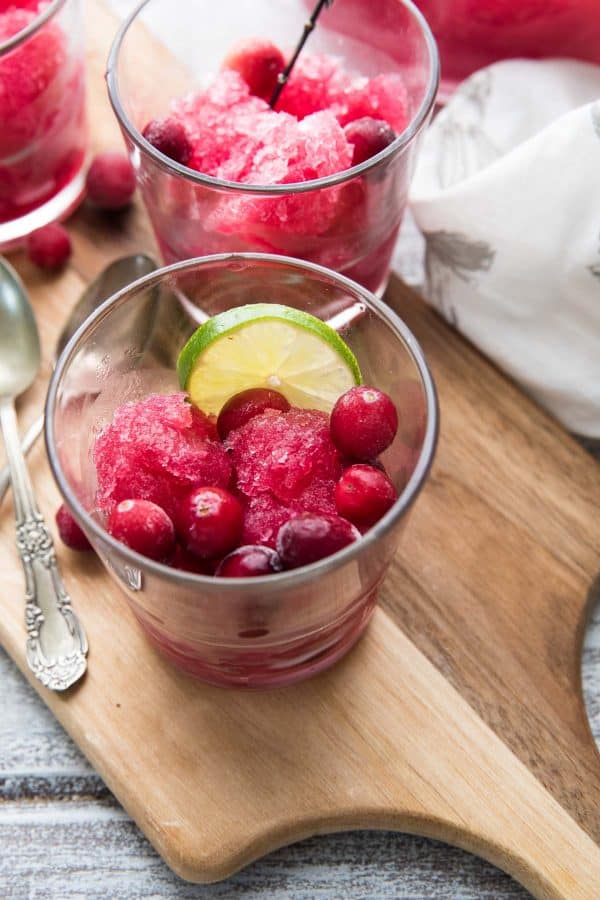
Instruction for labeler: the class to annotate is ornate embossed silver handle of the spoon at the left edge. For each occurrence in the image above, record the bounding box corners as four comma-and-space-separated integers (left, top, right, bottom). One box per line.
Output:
0, 397, 88, 691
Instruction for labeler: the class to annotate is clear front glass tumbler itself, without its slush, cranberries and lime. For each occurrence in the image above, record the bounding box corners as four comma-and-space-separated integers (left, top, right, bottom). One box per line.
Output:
46, 254, 438, 688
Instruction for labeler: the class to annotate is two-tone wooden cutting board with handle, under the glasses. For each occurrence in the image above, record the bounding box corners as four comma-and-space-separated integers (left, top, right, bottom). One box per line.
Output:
0, 2, 600, 900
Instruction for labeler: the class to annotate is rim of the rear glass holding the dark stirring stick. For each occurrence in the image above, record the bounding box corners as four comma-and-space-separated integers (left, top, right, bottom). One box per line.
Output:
105, 0, 440, 196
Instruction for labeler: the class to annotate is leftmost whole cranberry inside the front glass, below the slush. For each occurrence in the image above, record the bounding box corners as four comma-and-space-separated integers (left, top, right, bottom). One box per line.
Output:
108, 500, 175, 562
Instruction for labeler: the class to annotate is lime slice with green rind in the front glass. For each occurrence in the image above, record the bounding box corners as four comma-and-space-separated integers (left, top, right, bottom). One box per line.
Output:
177, 303, 362, 415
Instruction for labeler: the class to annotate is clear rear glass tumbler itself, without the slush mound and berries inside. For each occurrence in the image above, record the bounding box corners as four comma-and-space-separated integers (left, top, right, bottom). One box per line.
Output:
107, 0, 439, 295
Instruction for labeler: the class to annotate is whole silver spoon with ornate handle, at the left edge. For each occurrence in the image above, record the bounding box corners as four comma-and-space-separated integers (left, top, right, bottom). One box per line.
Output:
0, 259, 88, 691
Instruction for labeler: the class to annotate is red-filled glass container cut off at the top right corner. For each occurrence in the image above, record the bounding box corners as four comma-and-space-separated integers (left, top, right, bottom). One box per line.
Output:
415, 0, 600, 96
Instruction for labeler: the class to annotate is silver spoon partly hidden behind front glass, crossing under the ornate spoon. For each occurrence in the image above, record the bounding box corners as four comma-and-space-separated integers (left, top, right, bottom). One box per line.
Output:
0, 253, 157, 503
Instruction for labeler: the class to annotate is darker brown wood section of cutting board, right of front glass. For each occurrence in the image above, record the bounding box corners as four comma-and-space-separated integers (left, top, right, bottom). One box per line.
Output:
384, 284, 600, 840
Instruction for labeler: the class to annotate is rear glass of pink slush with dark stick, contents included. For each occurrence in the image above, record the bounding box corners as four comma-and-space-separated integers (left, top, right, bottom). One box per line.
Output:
108, 0, 437, 294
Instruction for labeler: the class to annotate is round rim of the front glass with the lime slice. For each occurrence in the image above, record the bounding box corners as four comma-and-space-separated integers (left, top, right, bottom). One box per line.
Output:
44, 253, 439, 594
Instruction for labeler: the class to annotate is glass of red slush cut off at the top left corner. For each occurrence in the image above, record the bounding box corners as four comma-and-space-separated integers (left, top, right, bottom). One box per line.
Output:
0, 0, 86, 250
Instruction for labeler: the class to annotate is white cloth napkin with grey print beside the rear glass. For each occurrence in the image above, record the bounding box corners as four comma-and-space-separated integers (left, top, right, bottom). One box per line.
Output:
411, 60, 600, 438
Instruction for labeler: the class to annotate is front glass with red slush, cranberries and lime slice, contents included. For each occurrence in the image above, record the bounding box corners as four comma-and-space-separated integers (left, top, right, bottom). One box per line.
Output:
46, 254, 437, 688
